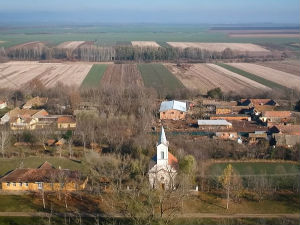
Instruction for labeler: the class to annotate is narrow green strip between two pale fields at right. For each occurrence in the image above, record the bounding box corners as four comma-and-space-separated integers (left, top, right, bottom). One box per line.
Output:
218, 63, 288, 90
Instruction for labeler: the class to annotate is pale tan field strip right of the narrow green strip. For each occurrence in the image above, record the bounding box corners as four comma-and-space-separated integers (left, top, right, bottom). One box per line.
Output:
228, 63, 300, 90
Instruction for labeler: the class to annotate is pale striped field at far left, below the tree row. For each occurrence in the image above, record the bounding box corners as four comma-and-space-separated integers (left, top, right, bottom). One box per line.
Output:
0, 61, 92, 88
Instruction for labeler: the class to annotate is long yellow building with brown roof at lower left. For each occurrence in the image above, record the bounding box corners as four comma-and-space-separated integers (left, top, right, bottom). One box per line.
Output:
0, 162, 88, 191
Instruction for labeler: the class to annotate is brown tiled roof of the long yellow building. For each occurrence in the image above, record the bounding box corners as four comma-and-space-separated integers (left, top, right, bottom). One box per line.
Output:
0, 163, 80, 183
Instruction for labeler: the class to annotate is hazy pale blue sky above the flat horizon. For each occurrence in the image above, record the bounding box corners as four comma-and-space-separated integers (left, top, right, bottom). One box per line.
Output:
0, 0, 300, 24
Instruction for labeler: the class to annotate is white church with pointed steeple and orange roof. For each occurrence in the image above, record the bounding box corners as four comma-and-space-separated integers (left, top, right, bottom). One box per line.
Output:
149, 127, 178, 189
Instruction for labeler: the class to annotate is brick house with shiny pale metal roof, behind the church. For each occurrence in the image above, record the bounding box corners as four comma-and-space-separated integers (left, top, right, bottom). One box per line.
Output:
159, 100, 187, 120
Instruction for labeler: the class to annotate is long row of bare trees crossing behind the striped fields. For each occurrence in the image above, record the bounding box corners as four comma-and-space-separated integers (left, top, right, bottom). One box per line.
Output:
0, 44, 278, 62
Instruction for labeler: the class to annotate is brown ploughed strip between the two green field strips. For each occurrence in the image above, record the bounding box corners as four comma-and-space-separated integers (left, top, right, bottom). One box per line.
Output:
101, 64, 143, 88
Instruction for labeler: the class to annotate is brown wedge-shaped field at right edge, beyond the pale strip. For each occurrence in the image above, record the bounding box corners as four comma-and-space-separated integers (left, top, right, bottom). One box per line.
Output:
255, 60, 300, 76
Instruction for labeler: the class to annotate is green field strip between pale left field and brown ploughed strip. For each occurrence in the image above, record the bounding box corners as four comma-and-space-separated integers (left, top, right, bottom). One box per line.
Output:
81, 64, 107, 88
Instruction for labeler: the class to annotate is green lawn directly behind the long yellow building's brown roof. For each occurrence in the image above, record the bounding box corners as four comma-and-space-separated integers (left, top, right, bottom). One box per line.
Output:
0, 157, 85, 177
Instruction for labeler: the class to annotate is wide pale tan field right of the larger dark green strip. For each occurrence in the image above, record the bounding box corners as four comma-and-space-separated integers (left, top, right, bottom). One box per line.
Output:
166, 64, 268, 94
